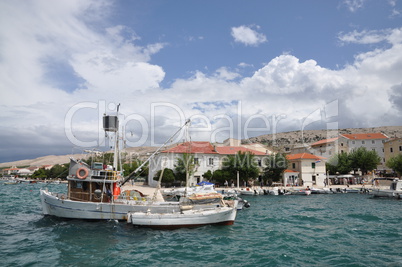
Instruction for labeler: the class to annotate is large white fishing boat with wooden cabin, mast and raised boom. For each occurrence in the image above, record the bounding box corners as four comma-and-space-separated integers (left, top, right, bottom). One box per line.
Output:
40, 108, 236, 225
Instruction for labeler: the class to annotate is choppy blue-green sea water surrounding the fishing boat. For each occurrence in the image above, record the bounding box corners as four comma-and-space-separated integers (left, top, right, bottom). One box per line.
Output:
0, 183, 402, 266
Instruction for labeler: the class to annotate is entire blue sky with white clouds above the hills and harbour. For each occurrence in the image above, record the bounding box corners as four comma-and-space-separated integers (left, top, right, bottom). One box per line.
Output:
0, 0, 402, 162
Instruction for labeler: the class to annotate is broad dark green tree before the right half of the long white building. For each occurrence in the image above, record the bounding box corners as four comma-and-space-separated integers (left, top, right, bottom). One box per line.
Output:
222, 151, 260, 186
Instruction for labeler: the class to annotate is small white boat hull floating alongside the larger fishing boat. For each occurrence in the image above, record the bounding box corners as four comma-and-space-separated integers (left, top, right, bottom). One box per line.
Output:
127, 207, 237, 229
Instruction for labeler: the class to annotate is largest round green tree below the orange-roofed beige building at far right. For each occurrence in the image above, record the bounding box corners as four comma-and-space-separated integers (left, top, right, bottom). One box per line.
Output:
349, 147, 381, 175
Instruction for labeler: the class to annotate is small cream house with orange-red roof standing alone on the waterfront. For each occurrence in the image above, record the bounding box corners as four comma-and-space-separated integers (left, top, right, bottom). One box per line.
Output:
284, 153, 326, 187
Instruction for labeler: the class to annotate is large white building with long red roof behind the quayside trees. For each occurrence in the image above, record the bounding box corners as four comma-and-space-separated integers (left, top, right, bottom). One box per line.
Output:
148, 141, 267, 186
